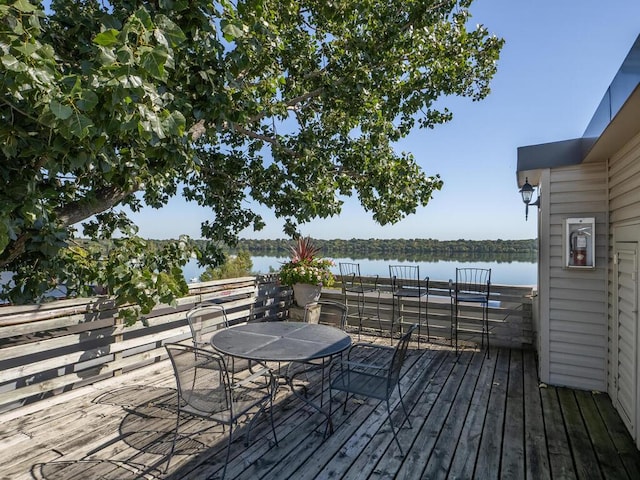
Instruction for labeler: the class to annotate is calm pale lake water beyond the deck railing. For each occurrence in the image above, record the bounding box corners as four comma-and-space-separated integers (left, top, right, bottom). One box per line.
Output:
183, 256, 538, 285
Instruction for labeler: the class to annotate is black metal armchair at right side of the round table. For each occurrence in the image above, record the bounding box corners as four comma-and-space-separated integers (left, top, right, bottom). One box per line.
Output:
329, 324, 418, 453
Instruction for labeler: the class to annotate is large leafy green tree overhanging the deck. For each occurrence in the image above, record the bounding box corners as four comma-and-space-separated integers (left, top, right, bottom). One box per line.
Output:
0, 0, 502, 318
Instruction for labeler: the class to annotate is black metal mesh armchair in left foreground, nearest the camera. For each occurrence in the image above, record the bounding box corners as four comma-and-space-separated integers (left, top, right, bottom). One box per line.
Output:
165, 344, 278, 478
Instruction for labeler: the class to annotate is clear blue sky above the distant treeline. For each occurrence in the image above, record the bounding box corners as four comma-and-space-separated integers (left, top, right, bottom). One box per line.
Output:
127, 0, 640, 240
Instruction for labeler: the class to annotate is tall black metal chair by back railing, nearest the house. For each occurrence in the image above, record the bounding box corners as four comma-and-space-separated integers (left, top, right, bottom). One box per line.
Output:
449, 268, 491, 357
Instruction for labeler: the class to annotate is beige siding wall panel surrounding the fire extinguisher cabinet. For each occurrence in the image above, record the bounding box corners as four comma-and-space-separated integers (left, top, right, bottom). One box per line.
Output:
538, 162, 609, 391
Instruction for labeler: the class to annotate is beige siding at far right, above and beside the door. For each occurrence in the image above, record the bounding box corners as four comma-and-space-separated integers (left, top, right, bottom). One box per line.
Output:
607, 134, 640, 398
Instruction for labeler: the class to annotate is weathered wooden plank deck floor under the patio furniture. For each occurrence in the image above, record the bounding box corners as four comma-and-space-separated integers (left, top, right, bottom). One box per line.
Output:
0, 338, 640, 480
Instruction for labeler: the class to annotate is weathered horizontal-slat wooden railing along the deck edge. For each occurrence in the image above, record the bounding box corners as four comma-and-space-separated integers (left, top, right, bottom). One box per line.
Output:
0, 275, 533, 412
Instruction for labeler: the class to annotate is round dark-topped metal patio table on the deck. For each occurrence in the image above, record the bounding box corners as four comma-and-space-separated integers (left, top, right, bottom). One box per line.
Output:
210, 322, 351, 432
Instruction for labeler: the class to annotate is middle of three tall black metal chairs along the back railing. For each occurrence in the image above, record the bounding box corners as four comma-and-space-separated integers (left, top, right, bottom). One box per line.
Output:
389, 265, 430, 348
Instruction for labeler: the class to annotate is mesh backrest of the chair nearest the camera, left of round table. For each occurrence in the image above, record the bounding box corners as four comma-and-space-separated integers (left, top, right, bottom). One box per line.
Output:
165, 343, 233, 416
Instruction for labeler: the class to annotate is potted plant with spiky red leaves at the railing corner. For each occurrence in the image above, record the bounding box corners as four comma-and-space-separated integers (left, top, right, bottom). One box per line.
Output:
280, 237, 335, 307
